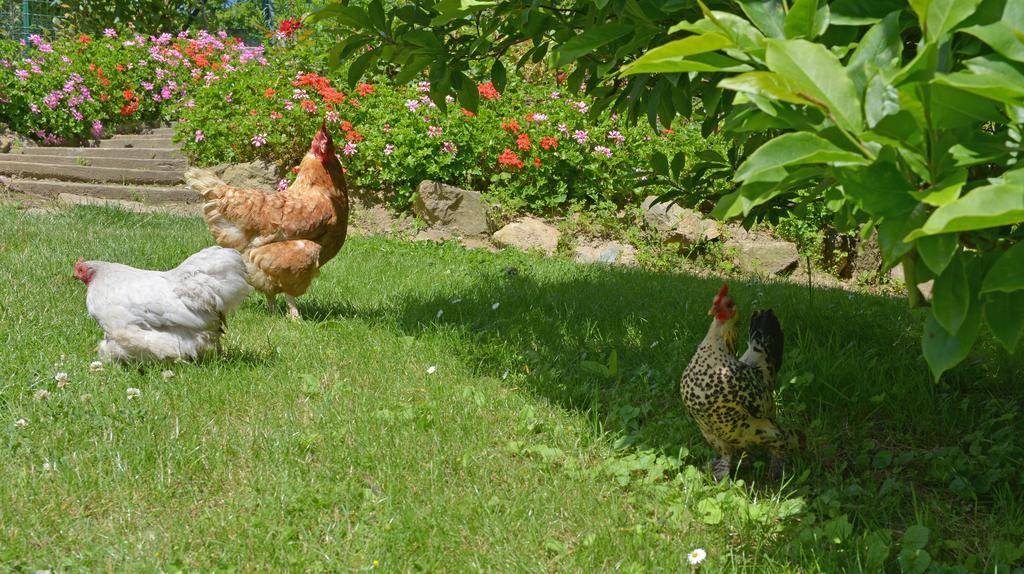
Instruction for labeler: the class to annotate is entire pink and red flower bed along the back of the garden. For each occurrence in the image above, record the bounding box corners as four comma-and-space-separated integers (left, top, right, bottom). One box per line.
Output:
0, 25, 724, 213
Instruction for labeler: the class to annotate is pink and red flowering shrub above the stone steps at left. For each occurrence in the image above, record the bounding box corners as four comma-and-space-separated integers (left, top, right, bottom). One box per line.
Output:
0, 29, 266, 143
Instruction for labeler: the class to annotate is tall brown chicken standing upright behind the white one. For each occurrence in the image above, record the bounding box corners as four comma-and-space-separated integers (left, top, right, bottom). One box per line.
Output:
185, 125, 348, 319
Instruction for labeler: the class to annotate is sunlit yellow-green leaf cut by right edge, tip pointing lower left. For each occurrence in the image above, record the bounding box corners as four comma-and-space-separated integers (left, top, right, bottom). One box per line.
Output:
905, 182, 1024, 241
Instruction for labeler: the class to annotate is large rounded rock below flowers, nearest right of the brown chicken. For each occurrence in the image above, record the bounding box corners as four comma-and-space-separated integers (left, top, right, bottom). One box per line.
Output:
413, 180, 492, 237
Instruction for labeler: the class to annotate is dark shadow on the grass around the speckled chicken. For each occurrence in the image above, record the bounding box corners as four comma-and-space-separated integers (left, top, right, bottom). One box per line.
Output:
321, 248, 1024, 552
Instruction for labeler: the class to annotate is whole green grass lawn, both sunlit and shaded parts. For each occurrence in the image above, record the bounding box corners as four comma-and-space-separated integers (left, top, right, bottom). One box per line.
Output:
0, 208, 1024, 572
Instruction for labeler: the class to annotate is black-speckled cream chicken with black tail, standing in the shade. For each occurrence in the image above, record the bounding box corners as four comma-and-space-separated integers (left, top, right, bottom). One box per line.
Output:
681, 284, 799, 480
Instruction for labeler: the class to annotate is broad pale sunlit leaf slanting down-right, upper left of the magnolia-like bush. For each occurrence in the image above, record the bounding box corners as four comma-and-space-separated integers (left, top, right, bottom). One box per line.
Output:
767, 40, 864, 133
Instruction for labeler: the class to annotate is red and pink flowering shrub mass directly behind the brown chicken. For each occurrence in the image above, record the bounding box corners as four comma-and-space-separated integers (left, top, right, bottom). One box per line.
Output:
182, 58, 711, 212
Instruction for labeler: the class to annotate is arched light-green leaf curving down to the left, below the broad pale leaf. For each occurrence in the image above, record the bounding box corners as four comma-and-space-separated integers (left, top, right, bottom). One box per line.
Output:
733, 132, 868, 182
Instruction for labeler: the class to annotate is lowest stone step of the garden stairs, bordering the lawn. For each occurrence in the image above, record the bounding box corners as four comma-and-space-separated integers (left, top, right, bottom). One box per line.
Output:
0, 177, 203, 205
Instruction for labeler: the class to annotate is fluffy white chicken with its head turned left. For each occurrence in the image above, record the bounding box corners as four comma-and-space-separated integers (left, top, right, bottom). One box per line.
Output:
75, 247, 252, 361
